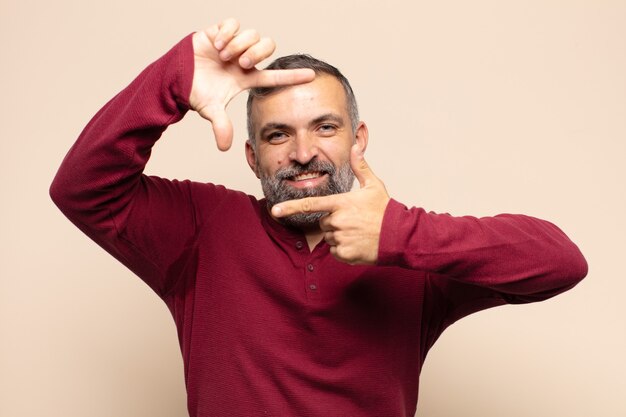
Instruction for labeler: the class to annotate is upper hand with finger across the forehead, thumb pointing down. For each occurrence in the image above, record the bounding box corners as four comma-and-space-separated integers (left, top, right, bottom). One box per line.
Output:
189, 19, 315, 151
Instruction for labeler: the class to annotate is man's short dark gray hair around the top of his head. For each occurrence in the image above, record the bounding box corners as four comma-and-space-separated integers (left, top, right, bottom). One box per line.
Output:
246, 54, 359, 143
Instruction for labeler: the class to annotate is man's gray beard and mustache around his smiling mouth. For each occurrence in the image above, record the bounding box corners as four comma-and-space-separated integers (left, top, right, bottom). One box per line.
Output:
261, 159, 354, 229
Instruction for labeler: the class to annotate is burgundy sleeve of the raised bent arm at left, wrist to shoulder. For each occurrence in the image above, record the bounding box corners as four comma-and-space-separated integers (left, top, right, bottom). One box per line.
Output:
50, 35, 219, 295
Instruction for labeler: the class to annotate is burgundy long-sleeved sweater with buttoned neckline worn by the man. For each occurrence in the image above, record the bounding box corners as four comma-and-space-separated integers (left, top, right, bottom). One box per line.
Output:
51, 37, 587, 417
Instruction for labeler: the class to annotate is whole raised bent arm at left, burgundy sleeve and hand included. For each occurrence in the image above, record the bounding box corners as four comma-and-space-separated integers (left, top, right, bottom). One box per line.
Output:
50, 20, 314, 292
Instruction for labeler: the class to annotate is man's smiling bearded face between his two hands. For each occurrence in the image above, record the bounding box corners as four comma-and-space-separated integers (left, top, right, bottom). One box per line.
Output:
246, 75, 367, 229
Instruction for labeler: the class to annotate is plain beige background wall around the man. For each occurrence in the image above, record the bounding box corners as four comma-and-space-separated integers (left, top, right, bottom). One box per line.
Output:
0, 0, 626, 417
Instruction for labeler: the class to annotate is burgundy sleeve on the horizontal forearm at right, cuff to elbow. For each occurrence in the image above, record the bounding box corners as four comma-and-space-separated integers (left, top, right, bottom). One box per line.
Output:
378, 200, 587, 302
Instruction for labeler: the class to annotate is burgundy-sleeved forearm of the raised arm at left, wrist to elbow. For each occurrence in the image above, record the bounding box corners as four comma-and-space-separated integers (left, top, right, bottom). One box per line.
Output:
50, 33, 193, 228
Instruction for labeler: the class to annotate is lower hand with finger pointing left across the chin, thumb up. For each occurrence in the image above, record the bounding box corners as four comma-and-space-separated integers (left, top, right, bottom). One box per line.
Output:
272, 144, 390, 265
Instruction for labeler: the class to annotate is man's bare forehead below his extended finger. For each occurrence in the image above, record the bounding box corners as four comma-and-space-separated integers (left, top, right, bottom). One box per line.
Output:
251, 75, 348, 132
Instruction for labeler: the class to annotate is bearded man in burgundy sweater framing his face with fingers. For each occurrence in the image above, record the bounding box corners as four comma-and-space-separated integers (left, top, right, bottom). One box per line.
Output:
51, 20, 587, 416
